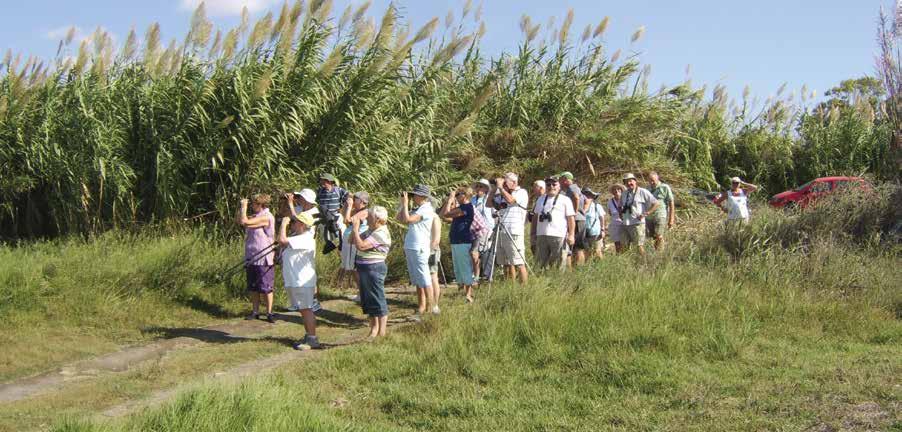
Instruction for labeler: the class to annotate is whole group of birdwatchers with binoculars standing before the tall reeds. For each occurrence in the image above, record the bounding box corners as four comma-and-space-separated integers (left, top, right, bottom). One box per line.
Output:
236, 171, 756, 349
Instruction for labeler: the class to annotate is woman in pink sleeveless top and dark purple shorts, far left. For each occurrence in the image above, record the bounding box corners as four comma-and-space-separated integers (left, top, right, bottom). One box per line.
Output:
236, 194, 276, 324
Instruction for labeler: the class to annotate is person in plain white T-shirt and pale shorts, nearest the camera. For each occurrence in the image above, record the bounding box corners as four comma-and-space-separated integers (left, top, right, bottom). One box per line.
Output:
279, 212, 320, 350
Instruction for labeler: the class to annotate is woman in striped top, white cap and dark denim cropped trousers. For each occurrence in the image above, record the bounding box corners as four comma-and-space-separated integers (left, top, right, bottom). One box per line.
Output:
351, 206, 391, 340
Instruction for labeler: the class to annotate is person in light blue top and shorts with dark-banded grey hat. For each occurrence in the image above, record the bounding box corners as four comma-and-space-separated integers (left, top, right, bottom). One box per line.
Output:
397, 184, 439, 321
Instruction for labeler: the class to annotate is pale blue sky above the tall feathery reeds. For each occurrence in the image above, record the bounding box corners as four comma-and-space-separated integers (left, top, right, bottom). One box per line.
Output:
0, 0, 892, 99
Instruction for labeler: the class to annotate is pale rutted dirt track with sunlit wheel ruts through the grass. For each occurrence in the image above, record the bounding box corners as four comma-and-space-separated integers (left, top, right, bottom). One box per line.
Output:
0, 287, 424, 410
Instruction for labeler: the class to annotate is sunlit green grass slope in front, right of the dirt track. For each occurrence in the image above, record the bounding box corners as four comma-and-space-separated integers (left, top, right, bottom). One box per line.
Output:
35, 199, 902, 431
